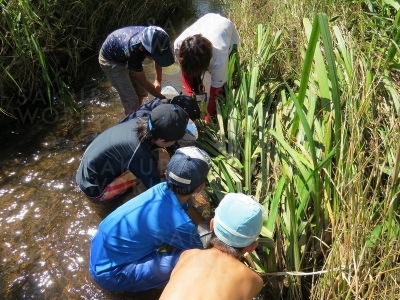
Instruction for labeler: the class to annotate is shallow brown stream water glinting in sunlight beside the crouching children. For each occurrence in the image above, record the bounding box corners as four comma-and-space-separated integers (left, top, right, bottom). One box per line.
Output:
0, 0, 221, 299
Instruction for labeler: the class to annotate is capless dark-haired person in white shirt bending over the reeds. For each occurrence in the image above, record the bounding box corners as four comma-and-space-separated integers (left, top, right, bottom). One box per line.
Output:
174, 13, 239, 116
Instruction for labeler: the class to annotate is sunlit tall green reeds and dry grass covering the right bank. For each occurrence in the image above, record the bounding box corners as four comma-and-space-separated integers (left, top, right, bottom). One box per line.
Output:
199, 1, 400, 299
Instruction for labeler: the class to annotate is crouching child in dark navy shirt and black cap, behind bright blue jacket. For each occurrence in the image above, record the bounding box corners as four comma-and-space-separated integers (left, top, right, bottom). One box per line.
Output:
76, 104, 189, 202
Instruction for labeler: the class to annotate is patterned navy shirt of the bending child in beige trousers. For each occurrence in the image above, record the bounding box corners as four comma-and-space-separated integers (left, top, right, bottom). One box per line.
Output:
100, 26, 146, 72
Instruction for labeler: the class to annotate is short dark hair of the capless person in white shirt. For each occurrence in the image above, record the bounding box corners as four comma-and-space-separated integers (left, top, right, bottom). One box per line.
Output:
177, 34, 213, 77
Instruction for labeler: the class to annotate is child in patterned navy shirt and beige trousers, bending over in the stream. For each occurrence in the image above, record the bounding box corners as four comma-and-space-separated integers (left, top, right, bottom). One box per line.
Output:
99, 26, 174, 115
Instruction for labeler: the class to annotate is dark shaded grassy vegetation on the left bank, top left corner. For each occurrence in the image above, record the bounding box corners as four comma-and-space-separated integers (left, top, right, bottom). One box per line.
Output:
0, 0, 188, 115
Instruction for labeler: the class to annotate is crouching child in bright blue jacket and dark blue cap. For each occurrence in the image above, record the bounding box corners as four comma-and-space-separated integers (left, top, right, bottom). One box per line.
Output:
89, 146, 210, 292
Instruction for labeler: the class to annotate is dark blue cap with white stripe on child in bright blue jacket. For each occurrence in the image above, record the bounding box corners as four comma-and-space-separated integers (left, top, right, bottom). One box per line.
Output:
167, 146, 211, 193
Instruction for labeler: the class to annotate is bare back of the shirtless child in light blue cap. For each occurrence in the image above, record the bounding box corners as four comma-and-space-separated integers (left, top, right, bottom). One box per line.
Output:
160, 248, 263, 300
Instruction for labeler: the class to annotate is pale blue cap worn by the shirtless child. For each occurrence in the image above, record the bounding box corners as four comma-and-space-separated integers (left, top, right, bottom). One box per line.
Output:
214, 193, 265, 248
